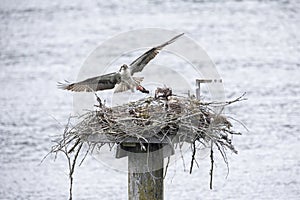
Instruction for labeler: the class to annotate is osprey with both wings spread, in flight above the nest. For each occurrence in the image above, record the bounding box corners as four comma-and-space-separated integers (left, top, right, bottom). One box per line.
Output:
58, 33, 184, 93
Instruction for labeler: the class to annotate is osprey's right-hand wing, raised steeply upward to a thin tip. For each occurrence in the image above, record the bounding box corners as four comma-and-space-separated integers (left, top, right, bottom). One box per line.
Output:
130, 33, 184, 75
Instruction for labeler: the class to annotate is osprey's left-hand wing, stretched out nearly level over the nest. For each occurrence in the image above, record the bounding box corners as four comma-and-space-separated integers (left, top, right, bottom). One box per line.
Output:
57, 73, 121, 92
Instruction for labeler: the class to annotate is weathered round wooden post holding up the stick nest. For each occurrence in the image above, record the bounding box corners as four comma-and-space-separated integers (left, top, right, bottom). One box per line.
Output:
127, 143, 164, 200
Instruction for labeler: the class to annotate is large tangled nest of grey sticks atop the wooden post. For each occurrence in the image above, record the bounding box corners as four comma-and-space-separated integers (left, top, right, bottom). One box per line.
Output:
61, 90, 241, 153
